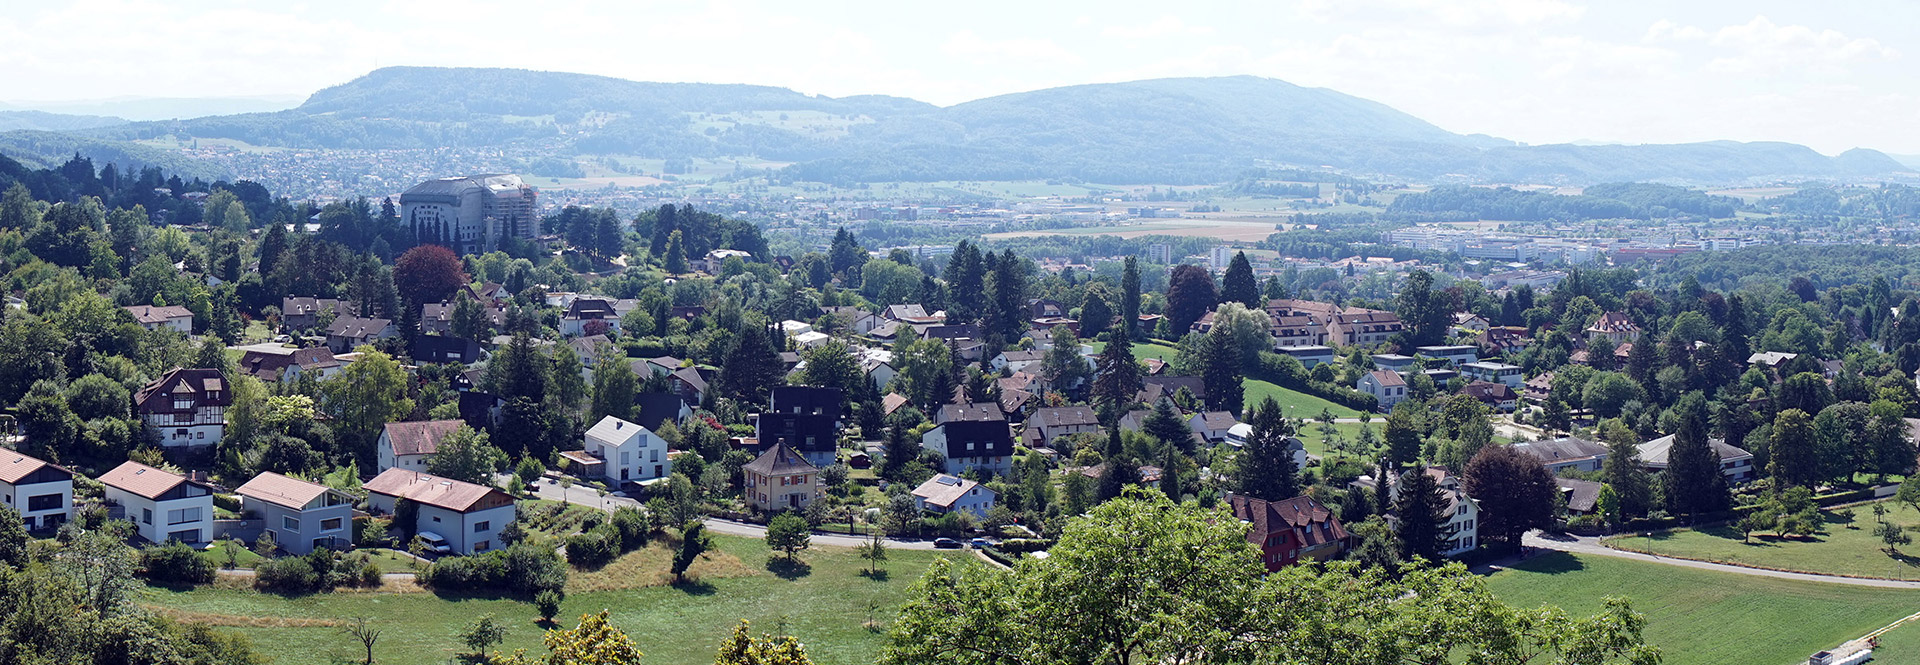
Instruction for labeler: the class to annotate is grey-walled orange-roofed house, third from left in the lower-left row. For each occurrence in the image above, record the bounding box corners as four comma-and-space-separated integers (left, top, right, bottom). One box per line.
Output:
234, 471, 353, 554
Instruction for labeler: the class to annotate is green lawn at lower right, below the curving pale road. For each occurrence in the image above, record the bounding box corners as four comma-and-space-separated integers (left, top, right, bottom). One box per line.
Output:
1486, 554, 1920, 665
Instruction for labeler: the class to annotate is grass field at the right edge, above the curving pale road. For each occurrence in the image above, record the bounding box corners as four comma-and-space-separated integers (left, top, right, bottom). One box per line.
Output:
1607, 502, 1920, 576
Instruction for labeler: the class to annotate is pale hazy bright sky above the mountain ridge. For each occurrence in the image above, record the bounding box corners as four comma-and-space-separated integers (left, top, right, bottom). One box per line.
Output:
0, 0, 1920, 154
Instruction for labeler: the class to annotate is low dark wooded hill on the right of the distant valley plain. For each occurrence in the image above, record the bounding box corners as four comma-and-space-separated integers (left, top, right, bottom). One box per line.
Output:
1382, 183, 1738, 223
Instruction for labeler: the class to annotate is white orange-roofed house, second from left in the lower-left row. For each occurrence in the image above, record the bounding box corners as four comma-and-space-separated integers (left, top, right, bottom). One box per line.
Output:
100, 461, 213, 544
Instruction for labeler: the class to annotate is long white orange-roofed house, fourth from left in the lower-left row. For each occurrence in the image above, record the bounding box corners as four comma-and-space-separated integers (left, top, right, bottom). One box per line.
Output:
361, 469, 518, 554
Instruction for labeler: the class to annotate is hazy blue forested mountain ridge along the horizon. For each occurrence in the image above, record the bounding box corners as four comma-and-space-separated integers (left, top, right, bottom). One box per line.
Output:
52, 67, 1912, 185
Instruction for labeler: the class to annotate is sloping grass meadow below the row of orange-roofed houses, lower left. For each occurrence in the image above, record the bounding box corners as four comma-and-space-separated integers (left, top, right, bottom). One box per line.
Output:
144, 536, 972, 665
